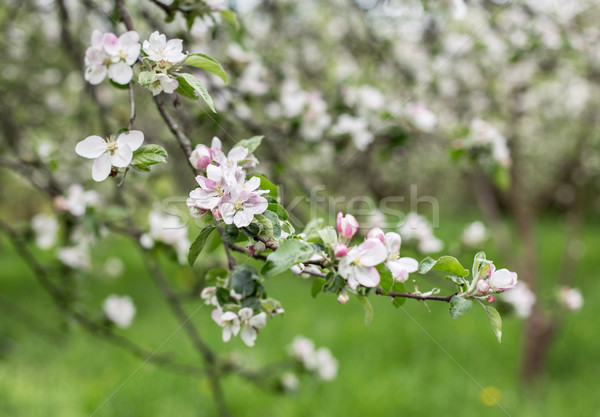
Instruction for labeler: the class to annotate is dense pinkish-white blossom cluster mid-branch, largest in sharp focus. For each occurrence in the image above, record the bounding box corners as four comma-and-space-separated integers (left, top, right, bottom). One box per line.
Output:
187, 137, 268, 227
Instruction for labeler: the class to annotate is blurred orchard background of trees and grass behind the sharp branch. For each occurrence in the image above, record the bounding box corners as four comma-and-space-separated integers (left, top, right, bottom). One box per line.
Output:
0, 0, 600, 417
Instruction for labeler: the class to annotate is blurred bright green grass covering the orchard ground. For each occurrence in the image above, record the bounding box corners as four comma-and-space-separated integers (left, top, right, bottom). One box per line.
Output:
0, 216, 600, 417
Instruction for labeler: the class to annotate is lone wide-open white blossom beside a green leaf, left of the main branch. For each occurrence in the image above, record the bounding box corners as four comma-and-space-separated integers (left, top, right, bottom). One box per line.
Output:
75, 130, 144, 181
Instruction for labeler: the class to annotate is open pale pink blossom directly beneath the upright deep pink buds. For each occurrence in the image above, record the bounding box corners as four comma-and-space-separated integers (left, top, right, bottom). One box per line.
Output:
338, 238, 387, 290
